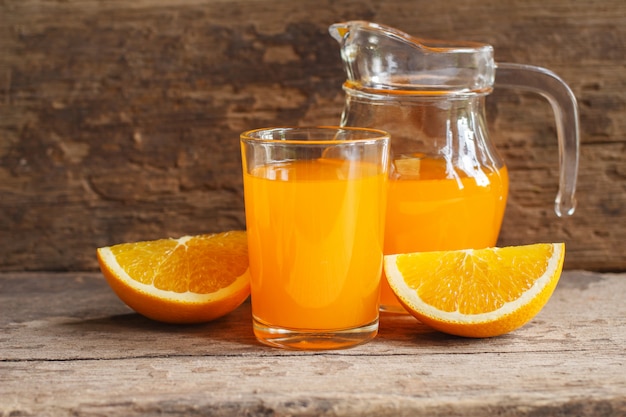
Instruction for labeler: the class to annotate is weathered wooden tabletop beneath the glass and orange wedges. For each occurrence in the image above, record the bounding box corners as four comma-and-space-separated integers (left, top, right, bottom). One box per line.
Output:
0, 271, 626, 417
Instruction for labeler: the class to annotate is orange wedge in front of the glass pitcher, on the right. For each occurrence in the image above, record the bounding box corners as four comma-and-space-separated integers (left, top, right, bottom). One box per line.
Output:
384, 243, 565, 337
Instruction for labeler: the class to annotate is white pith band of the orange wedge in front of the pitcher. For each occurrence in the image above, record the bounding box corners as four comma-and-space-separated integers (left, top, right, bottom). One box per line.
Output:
384, 244, 564, 323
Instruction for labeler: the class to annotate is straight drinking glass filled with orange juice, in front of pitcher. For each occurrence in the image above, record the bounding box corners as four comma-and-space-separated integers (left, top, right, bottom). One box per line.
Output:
241, 126, 389, 350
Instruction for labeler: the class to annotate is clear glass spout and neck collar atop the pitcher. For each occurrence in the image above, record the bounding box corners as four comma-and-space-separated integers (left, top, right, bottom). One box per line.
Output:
329, 21, 495, 95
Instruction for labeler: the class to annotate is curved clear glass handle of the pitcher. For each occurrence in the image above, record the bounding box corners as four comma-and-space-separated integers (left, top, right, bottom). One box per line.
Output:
495, 63, 580, 217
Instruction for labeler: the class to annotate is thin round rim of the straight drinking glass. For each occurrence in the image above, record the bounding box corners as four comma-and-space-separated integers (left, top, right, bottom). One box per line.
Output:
239, 125, 391, 146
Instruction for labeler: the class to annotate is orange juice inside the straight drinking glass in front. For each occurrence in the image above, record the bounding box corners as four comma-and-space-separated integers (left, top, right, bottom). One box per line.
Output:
244, 159, 386, 329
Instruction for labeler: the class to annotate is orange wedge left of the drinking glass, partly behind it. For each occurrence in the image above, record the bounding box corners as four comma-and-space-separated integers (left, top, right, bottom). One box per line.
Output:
97, 231, 250, 323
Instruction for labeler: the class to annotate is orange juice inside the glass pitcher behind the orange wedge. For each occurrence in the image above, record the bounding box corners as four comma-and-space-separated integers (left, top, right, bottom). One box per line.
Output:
380, 159, 508, 311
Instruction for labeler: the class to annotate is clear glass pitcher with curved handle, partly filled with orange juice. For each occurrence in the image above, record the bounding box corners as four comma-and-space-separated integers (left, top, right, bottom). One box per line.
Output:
329, 21, 579, 312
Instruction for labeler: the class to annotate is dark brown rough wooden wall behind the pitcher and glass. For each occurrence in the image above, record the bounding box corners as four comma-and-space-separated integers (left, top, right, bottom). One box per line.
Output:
0, 0, 626, 271
